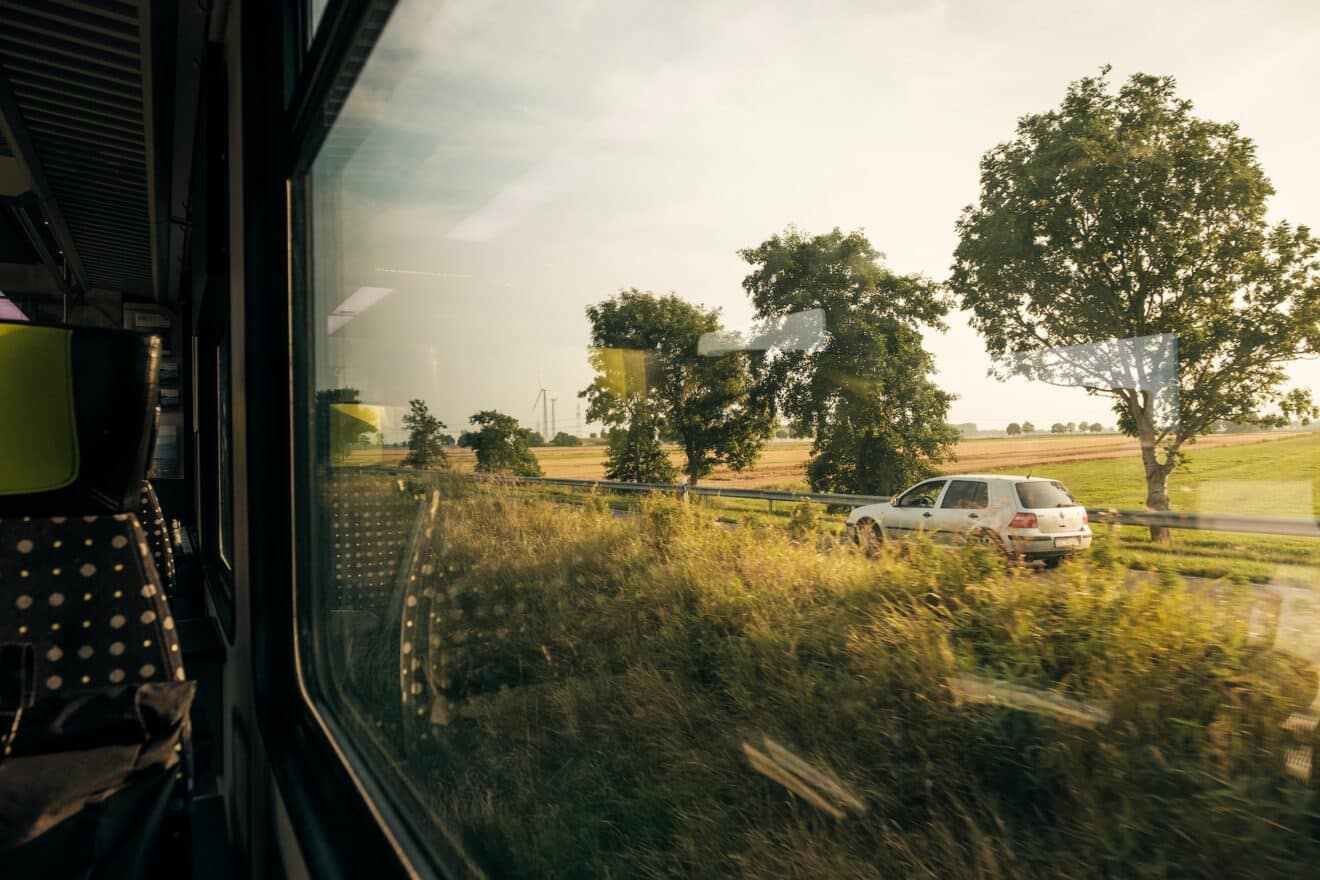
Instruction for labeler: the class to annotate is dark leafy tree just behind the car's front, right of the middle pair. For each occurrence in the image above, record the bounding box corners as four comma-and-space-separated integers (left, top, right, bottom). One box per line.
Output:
741, 227, 958, 493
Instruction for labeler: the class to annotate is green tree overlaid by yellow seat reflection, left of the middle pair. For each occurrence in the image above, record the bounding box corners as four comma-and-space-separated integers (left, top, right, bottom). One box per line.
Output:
581, 289, 775, 486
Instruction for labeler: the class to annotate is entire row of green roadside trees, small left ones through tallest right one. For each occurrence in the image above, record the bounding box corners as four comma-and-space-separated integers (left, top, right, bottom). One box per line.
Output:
322, 69, 1320, 537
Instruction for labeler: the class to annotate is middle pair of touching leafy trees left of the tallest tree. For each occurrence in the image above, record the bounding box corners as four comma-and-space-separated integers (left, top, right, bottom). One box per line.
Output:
582, 227, 958, 493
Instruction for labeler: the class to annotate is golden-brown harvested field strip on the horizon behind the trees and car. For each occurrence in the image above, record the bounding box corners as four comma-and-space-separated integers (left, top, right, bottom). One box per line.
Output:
352, 431, 1309, 487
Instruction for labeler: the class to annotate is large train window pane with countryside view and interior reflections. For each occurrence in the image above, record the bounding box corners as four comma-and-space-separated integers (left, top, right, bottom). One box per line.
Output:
299, 0, 1320, 877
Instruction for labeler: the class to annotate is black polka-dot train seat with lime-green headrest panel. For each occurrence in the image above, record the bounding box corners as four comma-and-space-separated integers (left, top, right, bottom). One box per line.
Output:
0, 323, 194, 879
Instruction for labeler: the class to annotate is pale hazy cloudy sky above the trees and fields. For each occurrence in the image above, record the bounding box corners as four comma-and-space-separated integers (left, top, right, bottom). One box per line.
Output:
312, 0, 1320, 439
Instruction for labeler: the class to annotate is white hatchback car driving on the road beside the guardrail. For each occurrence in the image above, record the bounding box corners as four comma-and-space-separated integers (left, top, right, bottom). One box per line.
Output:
847, 474, 1090, 565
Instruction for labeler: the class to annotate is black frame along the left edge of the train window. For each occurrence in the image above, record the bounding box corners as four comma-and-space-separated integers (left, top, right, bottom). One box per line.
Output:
242, 0, 473, 879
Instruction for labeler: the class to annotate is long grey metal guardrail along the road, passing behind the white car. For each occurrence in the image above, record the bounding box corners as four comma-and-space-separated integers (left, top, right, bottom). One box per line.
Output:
362, 467, 1320, 538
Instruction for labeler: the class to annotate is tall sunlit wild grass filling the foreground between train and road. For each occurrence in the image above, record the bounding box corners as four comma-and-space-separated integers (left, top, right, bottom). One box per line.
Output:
337, 480, 1320, 877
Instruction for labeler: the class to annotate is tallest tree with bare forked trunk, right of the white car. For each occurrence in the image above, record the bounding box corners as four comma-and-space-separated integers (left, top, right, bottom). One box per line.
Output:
949, 69, 1320, 540
